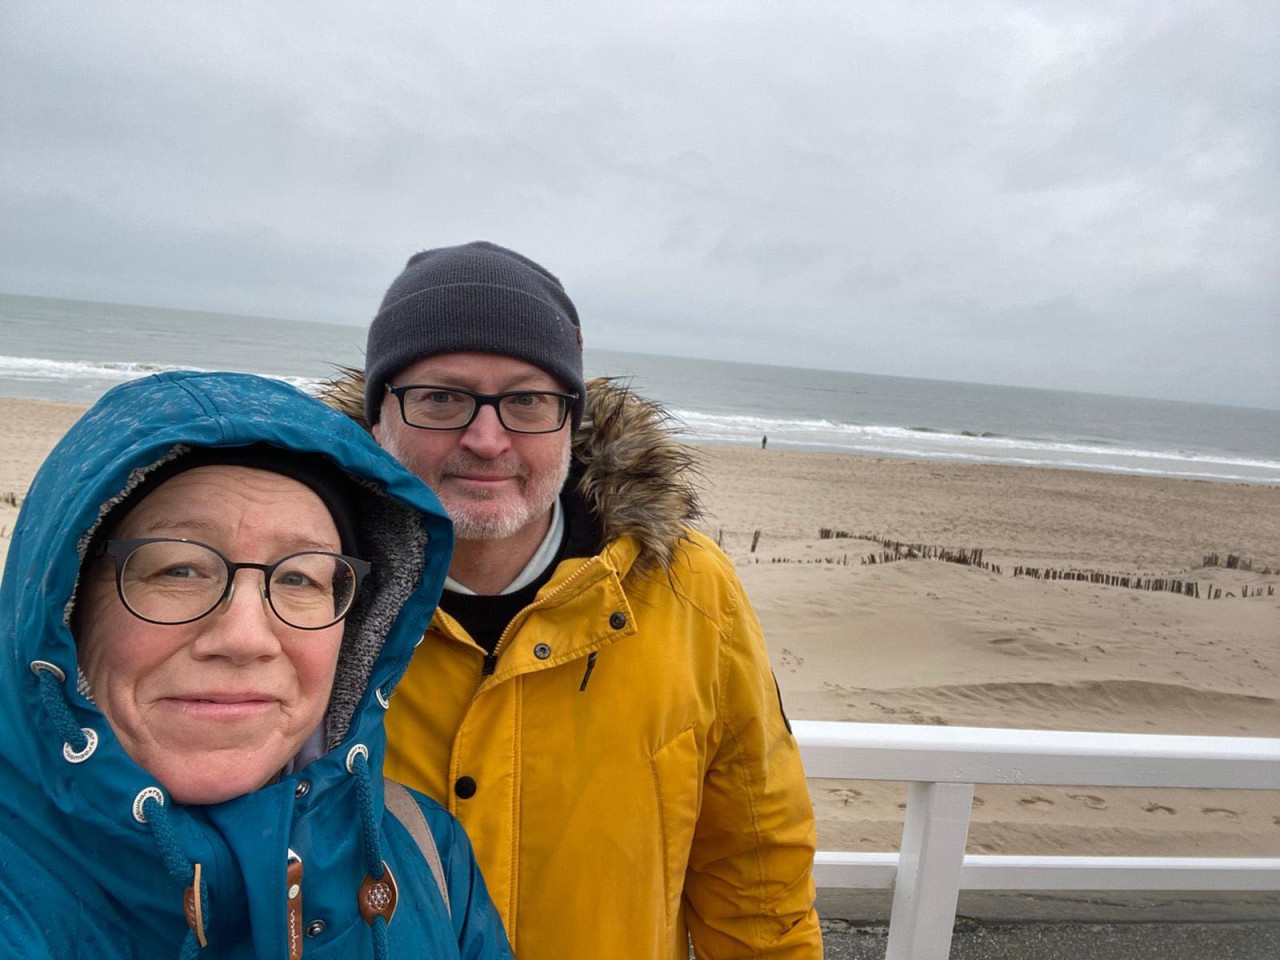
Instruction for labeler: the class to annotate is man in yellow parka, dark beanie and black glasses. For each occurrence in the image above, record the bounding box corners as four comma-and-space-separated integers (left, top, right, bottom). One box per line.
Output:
330, 243, 822, 960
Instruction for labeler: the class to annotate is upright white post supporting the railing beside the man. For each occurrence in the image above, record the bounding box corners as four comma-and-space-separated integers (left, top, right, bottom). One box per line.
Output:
884, 782, 973, 960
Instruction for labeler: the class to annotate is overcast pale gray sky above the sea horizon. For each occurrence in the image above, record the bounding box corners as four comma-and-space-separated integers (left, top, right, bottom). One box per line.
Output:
0, 0, 1280, 408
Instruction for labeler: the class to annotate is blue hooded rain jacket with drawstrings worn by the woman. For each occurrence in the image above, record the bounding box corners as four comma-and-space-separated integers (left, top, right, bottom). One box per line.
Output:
0, 372, 511, 960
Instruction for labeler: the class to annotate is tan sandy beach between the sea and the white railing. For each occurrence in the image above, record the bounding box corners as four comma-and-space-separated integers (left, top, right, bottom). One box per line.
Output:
0, 398, 1280, 856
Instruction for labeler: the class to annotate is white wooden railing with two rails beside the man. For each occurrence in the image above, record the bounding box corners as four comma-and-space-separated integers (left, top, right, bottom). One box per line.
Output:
792, 721, 1280, 960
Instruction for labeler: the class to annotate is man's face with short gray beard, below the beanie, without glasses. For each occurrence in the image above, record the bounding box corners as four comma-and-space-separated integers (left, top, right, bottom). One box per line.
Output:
374, 353, 571, 540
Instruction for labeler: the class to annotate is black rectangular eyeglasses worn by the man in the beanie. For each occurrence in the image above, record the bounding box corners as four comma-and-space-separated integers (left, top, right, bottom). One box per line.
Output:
387, 384, 577, 434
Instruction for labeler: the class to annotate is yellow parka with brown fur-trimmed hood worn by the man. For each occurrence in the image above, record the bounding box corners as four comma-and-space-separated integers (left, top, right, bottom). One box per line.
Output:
325, 380, 822, 960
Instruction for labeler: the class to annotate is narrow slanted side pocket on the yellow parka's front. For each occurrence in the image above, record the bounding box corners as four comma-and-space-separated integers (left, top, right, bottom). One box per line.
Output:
650, 727, 703, 925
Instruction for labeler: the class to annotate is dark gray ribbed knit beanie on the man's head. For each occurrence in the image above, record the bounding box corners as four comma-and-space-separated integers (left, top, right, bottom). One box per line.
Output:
365, 241, 586, 428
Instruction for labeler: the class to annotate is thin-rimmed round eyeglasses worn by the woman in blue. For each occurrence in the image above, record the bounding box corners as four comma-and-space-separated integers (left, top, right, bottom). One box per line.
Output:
99, 538, 370, 630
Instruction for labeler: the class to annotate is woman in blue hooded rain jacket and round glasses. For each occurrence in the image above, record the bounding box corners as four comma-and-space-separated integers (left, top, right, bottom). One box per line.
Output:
0, 374, 511, 960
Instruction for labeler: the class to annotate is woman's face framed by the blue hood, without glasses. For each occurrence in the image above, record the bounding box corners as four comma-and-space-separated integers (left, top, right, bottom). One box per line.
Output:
79, 466, 343, 804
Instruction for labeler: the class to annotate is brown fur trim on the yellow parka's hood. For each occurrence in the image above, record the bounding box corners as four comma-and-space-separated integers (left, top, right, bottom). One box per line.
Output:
320, 367, 701, 572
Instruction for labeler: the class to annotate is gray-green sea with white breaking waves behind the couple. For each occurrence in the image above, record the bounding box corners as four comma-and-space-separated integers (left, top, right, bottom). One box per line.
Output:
0, 293, 1280, 485
